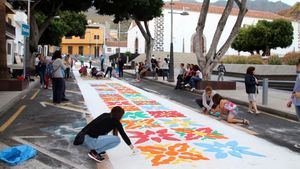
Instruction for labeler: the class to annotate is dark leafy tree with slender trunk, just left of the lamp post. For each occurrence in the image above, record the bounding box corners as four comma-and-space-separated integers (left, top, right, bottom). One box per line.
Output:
94, 0, 164, 64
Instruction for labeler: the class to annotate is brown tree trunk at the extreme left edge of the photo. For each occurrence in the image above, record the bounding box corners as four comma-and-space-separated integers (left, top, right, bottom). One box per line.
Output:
0, 0, 9, 79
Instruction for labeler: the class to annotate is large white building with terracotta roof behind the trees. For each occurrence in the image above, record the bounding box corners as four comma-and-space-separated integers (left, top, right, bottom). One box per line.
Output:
128, 2, 300, 55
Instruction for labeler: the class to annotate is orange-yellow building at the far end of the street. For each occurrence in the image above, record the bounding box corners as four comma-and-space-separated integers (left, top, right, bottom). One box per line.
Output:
61, 24, 104, 57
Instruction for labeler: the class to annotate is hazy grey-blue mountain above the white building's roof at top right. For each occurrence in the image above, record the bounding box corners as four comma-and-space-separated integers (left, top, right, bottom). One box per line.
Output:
179, 0, 291, 12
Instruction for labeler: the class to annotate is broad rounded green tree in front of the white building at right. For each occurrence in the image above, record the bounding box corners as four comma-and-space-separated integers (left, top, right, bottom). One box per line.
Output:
232, 19, 294, 56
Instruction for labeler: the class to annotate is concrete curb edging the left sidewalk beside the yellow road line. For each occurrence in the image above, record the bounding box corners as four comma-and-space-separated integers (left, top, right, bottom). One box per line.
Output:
0, 79, 39, 114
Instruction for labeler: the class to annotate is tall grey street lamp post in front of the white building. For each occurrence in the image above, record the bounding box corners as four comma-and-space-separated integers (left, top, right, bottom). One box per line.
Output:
168, 0, 189, 82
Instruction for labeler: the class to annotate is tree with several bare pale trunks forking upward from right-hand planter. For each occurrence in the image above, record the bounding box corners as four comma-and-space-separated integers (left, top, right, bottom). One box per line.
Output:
195, 0, 248, 80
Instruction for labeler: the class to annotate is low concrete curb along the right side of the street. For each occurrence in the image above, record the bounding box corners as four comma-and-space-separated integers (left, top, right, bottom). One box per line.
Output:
124, 72, 298, 121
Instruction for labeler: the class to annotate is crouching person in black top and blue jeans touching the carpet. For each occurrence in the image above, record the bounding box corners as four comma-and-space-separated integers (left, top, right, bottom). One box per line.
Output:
74, 106, 134, 162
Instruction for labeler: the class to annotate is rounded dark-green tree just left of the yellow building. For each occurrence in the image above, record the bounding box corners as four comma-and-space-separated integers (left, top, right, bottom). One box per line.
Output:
36, 11, 87, 46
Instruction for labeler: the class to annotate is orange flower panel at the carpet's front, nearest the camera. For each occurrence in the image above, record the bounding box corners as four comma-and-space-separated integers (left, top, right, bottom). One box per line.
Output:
137, 143, 209, 166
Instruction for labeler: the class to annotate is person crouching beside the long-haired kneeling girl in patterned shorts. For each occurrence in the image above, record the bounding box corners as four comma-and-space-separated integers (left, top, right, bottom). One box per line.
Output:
196, 86, 217, 114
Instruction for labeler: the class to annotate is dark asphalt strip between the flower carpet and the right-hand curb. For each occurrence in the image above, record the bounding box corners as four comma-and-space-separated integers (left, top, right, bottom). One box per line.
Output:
124, 76, 300, 153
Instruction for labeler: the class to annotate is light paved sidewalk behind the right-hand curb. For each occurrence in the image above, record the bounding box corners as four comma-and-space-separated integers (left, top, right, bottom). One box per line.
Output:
125, 70, 297, 120
